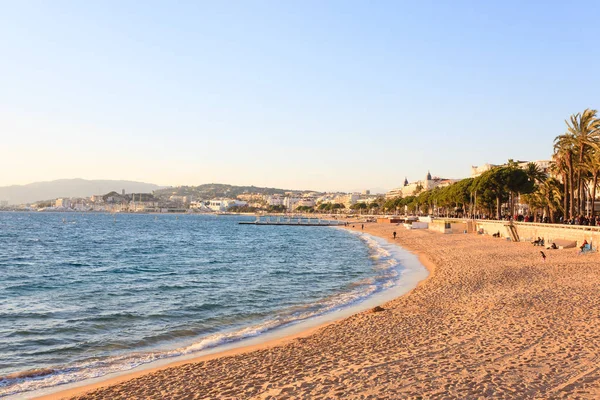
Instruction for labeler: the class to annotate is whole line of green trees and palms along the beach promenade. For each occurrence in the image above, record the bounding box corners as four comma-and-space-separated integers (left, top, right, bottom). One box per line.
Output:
382, 109, 600, 223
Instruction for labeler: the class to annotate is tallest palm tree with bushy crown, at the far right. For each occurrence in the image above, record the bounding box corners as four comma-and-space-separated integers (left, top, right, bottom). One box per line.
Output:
565, 108, 600, 213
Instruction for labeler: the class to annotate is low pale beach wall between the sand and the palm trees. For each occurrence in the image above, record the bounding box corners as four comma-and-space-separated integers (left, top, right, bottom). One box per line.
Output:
476, 220, 600, 246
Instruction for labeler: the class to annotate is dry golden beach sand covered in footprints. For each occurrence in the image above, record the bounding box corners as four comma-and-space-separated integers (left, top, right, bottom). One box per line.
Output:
42, 223, 600, 399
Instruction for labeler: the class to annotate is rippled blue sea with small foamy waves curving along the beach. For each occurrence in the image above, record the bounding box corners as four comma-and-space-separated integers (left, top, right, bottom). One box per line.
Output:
0, 213, 420, 396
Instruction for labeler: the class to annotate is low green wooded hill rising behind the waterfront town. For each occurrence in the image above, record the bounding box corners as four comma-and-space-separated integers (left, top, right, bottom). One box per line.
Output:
154, 183, 312, 199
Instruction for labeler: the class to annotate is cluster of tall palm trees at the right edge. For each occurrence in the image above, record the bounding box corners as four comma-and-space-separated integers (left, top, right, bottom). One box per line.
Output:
552, 109, 600, 219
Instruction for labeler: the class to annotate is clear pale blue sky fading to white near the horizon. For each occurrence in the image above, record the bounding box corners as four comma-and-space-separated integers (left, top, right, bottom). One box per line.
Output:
0, 0, 600, 190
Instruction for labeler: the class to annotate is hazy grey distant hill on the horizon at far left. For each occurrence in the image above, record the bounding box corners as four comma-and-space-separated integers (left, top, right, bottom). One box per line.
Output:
0, 179, 164, 204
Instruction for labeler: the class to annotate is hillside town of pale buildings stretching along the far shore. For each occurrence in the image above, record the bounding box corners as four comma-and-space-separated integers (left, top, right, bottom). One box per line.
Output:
0, 160, 552, 219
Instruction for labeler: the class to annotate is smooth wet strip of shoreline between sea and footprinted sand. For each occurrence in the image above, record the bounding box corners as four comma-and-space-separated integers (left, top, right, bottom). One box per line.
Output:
27, 225, 435, 400
